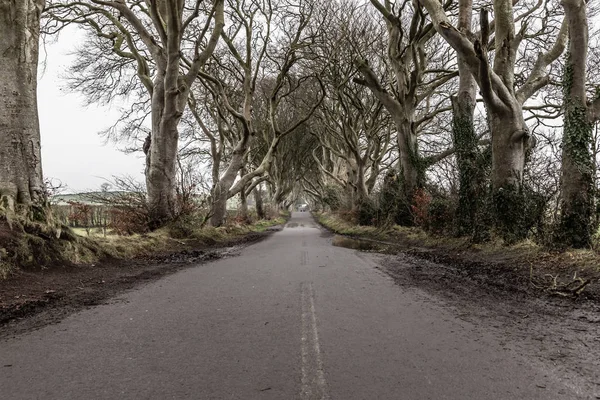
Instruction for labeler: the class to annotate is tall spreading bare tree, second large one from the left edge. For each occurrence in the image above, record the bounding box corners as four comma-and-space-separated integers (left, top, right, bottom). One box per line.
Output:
48, 0, 225, 228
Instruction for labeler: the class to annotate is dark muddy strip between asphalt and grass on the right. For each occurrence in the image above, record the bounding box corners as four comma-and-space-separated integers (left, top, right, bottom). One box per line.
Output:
325, 230, 600, 399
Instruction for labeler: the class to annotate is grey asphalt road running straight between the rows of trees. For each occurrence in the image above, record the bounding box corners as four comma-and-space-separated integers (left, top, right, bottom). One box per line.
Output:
0, 213, 585, 400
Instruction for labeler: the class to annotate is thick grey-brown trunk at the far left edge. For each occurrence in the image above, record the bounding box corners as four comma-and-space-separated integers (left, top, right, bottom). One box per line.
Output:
0, 0, 46, 214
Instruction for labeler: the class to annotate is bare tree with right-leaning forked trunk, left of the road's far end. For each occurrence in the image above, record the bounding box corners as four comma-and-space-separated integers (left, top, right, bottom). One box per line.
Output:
200, 0, 324, 226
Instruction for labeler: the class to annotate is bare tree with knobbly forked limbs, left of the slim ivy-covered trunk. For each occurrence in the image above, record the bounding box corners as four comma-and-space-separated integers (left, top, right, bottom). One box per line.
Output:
354, 0, 456, 224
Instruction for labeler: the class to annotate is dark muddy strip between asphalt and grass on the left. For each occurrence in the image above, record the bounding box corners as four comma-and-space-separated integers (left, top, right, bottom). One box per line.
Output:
0, 226, 281, 339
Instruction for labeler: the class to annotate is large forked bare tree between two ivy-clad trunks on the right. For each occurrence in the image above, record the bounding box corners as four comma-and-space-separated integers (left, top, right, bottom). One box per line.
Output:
420, 0, 567, 241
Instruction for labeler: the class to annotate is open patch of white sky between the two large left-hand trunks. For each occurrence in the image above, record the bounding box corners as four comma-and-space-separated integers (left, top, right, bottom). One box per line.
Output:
38, 29, 144, 192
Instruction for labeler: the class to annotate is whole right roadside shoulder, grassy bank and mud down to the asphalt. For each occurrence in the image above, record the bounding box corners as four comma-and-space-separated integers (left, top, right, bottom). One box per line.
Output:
316, 215, 600, 399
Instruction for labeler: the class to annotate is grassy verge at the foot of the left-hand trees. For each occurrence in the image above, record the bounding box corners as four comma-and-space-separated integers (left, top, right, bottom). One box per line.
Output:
0, 215, 287, 279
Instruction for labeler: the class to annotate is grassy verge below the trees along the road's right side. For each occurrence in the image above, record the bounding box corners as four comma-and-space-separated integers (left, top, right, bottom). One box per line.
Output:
315, 213, 600, 299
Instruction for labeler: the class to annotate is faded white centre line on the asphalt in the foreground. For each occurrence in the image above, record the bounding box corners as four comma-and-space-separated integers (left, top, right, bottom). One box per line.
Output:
300, 282, 329, 400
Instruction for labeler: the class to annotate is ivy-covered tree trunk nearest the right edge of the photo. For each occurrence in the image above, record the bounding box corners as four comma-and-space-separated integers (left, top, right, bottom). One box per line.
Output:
556, 0, 594, 248
